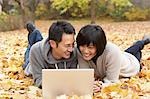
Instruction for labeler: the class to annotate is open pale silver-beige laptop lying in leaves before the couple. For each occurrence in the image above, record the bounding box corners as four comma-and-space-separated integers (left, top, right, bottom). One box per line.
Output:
42, 69, 94, 99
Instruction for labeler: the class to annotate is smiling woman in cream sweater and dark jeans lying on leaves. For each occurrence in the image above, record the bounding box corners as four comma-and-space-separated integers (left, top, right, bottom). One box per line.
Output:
76, 25, 150, 89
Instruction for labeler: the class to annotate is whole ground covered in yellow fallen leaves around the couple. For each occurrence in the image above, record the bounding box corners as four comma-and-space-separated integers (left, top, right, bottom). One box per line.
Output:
0, 20, 150, 99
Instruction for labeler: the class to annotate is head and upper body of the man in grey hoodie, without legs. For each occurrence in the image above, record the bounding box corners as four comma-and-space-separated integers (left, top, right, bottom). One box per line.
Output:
29, 21, 77, 88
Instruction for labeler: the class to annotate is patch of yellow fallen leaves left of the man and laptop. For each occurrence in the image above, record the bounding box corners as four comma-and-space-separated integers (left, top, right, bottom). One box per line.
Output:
0, 31, 42, 99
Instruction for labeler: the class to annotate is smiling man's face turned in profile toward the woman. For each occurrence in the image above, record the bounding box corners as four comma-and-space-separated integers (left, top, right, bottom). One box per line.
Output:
52, 33, 75, 59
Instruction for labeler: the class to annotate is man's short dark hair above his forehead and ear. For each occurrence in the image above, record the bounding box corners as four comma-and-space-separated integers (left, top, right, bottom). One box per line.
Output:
48, 21, 75, 43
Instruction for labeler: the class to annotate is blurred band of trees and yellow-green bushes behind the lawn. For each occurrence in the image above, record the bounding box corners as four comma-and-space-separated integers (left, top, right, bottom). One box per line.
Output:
0, 0, 150, 31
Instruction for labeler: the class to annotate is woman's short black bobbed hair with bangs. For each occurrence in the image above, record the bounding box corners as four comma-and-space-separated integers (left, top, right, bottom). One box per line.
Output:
76, 24, 107, 57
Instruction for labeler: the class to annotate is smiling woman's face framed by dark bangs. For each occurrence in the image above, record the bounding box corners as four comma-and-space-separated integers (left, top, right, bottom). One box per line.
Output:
79, 44, 96, 61
